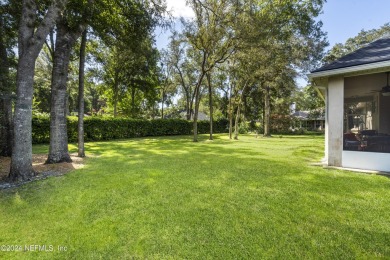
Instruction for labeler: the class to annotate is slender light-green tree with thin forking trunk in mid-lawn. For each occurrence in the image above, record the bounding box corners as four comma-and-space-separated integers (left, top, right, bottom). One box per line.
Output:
185, 0, 237, 142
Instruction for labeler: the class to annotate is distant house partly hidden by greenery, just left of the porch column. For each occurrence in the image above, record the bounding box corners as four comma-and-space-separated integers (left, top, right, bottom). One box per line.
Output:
292, 111, 325, 131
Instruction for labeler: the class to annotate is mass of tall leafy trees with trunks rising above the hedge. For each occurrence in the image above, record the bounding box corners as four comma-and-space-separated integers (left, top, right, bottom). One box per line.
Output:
4, 0, 327, 180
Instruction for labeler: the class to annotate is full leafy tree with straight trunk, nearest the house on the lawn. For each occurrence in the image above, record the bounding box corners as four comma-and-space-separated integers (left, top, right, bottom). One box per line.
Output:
236, 0, 327, 136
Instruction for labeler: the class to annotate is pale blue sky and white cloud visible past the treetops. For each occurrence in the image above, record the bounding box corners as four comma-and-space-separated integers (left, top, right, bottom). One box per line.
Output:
156, 0, 390, 85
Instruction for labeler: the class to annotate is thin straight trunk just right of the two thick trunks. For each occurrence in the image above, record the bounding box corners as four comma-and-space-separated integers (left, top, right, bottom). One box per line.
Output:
77, 28, 87, 157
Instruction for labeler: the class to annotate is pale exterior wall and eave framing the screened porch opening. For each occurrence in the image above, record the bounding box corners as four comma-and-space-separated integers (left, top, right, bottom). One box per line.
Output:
309, 64, 390, 172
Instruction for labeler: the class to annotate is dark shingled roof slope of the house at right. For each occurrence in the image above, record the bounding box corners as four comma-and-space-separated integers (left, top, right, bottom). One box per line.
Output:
311, 35, 390, 73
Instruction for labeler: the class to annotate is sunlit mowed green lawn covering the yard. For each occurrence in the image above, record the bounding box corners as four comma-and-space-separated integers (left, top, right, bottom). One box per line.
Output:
0, 135, 390, 259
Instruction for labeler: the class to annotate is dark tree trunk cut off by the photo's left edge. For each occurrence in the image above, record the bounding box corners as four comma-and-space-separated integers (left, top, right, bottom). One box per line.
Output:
0, 17, 12, 157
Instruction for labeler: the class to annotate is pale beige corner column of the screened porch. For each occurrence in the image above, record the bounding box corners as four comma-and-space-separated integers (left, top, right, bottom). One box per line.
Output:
325, 77, 344, 166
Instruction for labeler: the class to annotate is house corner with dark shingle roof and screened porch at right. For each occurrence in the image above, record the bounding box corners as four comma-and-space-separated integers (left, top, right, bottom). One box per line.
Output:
308, 37, 390, 172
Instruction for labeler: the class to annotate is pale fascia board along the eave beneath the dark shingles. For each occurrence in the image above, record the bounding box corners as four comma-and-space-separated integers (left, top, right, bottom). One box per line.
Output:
307, 60, 390, 80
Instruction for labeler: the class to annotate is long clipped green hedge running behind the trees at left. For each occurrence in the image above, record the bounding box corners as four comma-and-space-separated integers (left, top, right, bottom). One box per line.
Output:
32, 116, 229, 143
